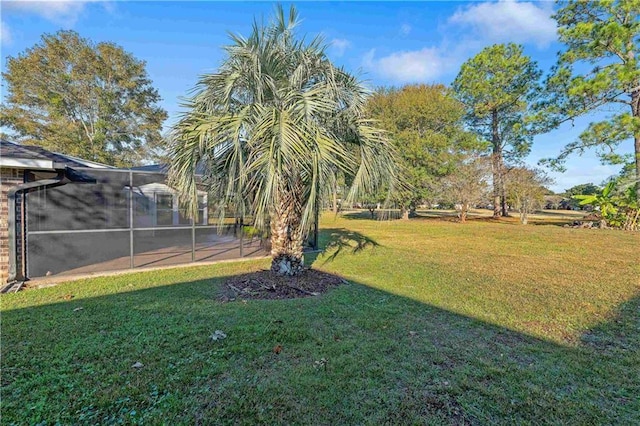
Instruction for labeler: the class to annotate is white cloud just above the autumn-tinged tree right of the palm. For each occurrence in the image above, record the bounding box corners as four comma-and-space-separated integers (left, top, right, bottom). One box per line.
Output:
363, 47, 459, 83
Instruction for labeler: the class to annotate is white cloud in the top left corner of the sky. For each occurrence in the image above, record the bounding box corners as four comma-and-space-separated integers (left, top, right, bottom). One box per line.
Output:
2, 0, 105, 26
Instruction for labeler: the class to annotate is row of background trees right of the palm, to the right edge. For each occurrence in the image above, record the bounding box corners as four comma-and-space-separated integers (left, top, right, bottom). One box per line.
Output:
334, 0, 640, 229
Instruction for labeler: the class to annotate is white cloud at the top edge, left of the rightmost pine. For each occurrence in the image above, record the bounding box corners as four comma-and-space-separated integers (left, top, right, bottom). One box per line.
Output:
449, 0, 557, 48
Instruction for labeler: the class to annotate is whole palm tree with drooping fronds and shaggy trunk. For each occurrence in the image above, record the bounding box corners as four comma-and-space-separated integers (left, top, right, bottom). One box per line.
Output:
170, 6, 395, 275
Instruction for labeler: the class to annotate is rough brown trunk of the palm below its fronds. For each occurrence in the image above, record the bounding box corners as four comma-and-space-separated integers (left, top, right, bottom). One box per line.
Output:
270, 187, 304, 275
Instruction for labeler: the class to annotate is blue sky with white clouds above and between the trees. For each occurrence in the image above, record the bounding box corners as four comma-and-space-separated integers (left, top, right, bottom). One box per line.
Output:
0, 0, 632, 191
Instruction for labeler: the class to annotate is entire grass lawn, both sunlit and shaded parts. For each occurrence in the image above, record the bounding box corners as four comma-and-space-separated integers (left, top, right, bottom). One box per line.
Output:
0, 215, 640, 425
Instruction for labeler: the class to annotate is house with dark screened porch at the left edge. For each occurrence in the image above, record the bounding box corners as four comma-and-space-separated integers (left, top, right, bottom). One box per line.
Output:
0, 141, 255, 282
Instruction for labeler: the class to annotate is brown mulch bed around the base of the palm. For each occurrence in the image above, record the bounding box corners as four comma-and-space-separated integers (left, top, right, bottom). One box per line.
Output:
220, 269, 346, 302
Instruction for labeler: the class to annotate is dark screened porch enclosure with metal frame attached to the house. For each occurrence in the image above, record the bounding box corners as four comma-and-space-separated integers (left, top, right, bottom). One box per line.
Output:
16, 168, 288, 278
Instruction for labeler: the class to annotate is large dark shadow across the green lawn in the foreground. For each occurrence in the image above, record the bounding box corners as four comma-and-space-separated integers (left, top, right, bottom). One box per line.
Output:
1, 256, 640, 424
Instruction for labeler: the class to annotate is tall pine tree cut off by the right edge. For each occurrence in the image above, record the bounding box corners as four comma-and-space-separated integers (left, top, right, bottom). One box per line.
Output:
546, 0, 640, 199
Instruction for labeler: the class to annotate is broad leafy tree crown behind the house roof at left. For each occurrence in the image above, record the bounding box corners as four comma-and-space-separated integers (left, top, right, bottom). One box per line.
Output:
0, 31, 167, 166
